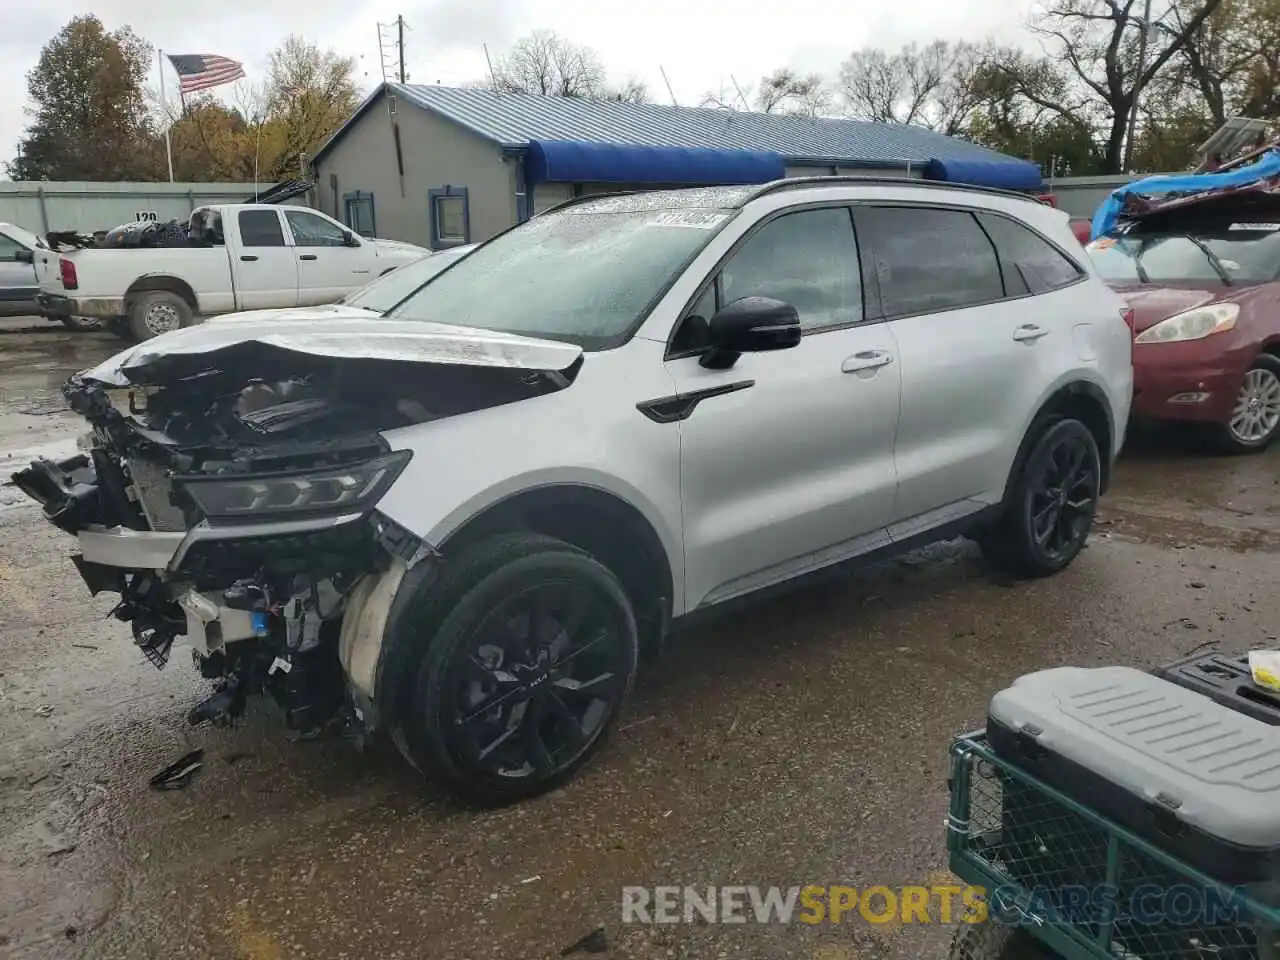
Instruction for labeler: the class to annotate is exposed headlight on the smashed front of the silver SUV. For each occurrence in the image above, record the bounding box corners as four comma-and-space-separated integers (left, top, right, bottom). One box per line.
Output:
179, 451, 412, 522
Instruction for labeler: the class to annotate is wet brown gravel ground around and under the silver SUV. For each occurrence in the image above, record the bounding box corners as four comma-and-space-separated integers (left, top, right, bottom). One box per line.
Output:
0, 321, 1280, 960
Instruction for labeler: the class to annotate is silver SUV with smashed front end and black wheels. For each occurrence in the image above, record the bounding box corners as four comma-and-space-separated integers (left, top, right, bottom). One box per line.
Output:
17, 178, 1133, 801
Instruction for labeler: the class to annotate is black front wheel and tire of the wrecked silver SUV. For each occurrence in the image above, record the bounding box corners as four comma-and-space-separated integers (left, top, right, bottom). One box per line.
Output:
393, 534, 639, 805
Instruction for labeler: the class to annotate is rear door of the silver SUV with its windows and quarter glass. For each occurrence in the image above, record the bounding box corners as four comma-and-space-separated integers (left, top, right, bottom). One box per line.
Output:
855, 205, 1082, 529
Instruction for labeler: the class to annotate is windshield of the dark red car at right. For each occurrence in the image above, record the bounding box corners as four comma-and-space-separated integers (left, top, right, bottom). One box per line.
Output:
1088, 223, 1280, 285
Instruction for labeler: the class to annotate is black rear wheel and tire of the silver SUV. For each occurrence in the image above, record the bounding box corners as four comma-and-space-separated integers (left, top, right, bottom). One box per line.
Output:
979, 419, 1102, 577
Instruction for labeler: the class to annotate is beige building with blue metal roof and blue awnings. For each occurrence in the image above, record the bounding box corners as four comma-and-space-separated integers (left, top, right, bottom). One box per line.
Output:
312, 83, 1041, 250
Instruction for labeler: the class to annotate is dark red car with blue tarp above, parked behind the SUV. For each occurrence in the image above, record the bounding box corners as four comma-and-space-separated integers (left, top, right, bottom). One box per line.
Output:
1088, 216, 1280, 452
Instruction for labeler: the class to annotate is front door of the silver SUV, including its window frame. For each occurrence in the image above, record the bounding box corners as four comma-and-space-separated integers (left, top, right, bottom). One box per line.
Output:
667, 206, 899, 608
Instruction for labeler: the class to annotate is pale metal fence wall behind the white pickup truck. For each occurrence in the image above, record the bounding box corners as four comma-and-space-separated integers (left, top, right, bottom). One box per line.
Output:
0, 180, 314, 236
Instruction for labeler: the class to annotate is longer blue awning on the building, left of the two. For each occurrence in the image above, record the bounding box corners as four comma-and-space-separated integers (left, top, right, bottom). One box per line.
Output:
525, 140, 787, 186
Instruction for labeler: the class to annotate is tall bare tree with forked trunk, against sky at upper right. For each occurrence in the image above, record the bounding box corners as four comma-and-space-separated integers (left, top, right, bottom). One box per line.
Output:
1008, 0, 1222, 173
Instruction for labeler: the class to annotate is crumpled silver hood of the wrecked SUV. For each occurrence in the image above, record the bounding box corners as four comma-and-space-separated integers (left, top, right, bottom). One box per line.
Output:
81, 317, 582, 387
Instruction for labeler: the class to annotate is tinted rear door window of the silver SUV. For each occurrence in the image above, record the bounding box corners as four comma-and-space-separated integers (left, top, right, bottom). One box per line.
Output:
854, 206, 1005, 317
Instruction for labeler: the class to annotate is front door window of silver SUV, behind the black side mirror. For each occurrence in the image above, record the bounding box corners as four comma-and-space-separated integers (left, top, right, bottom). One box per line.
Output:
721, 207, 863, 330
